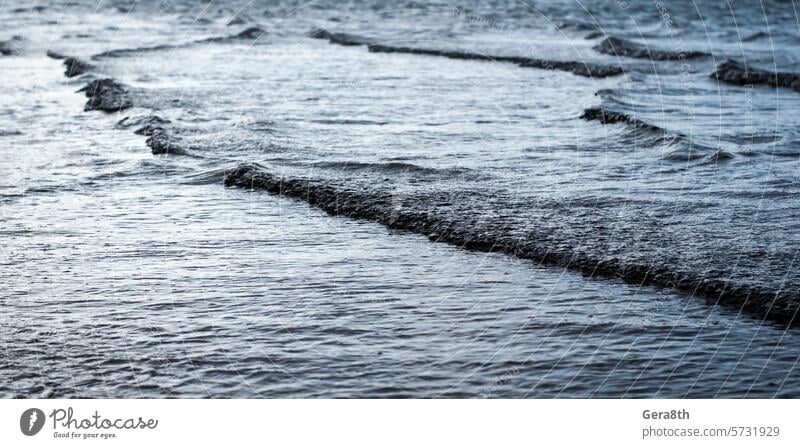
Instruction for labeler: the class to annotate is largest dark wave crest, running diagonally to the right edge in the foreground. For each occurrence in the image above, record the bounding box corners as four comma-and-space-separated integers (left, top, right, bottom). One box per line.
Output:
224, 164, 800, 324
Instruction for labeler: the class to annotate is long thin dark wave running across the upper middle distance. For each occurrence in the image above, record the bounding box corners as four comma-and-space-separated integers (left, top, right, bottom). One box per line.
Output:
311, 30, 623, 78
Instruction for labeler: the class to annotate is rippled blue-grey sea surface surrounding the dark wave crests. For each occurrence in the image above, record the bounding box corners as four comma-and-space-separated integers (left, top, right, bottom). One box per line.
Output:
0, 1, 800, 397
